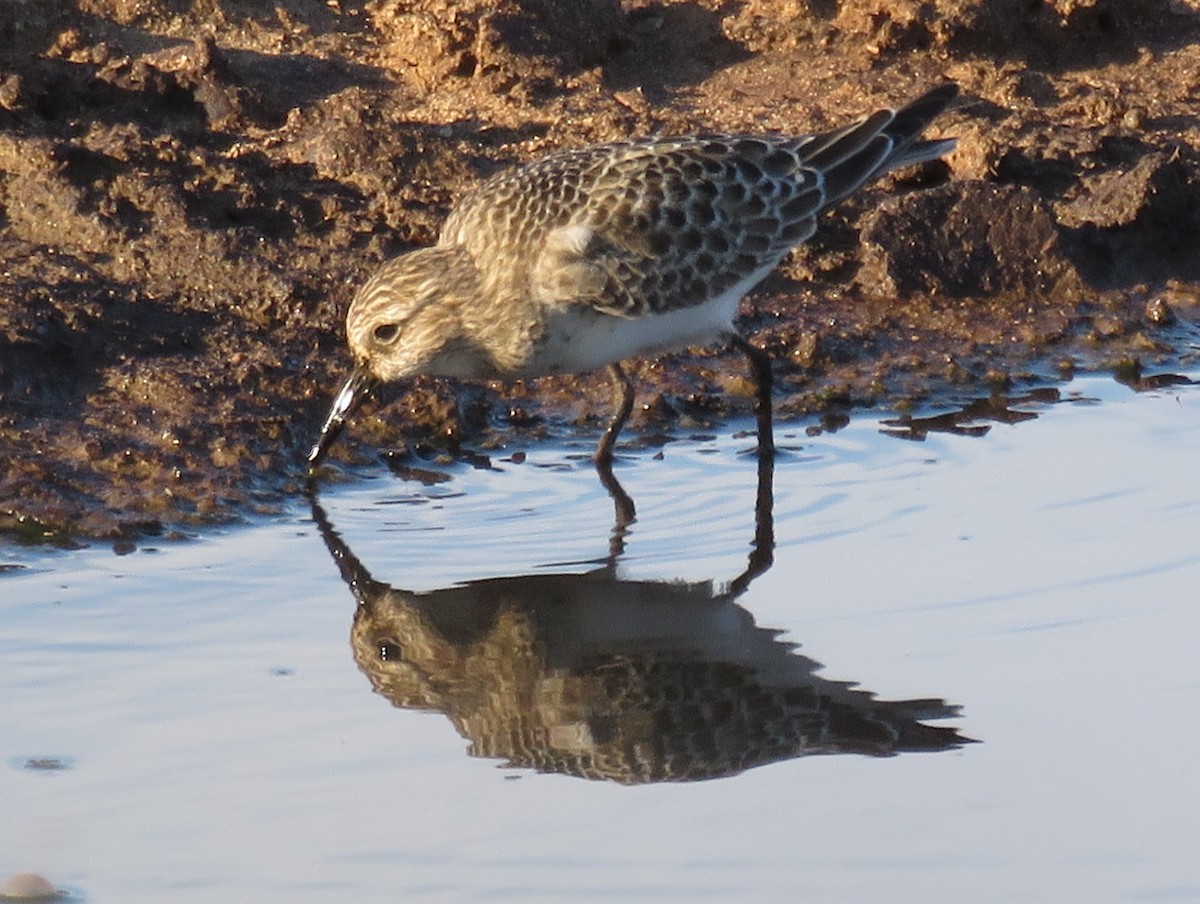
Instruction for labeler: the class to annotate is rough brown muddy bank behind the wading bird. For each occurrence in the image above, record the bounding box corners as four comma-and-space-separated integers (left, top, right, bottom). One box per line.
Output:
0, 0, 1200, 541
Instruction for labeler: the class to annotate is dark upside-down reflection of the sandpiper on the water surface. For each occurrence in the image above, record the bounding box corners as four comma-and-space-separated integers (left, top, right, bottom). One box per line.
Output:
312, 456, 968, 784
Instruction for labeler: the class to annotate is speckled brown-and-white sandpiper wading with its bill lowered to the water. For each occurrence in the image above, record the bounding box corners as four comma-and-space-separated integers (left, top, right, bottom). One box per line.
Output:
307, 82, 958, 473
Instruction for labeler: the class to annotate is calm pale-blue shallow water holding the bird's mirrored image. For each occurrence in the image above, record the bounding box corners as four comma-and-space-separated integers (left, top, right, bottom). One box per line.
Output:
0, 373, 1200, 903
